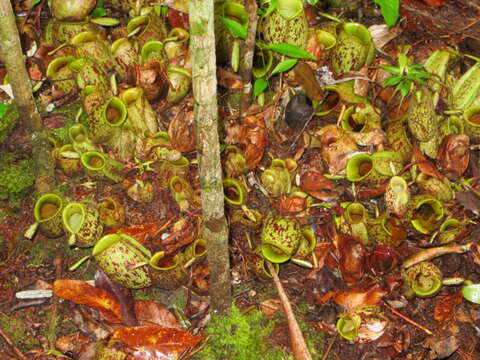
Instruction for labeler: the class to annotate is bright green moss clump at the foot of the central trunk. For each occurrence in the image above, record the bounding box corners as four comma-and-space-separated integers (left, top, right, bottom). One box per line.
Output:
194, 305, 285, 360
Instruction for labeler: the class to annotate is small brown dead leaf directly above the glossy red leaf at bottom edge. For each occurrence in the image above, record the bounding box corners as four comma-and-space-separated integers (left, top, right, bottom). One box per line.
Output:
135, 300, 180, 328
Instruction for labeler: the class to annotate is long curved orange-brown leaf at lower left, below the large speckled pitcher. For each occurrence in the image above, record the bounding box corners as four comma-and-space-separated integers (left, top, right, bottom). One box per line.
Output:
53, 279, 123, 323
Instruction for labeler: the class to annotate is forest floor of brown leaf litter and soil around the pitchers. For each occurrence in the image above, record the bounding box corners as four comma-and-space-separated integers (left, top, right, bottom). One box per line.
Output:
0, 0, 480, 360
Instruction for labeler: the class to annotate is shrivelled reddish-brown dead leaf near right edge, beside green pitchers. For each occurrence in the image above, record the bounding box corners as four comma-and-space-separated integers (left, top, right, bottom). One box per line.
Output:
437, 134, 470, 178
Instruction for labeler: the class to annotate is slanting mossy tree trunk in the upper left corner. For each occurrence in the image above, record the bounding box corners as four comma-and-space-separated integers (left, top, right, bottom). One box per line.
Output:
0, 0, 55, 193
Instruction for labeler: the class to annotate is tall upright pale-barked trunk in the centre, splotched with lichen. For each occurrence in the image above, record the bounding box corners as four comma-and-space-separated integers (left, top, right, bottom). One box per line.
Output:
189, 0, 231, 313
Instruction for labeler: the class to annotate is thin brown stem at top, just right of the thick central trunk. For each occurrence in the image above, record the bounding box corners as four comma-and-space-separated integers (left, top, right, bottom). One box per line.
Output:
240, 0, 258, 118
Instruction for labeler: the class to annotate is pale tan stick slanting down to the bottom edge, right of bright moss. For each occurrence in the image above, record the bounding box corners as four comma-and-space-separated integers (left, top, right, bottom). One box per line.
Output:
266, 261, 312, 360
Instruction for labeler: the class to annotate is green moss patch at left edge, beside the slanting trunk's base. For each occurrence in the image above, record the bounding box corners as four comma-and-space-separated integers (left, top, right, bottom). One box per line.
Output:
0, 153, 35, 201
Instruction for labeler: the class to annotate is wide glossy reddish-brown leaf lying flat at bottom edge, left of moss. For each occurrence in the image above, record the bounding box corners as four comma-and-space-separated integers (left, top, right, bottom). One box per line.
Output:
109, 326, 201, 360
